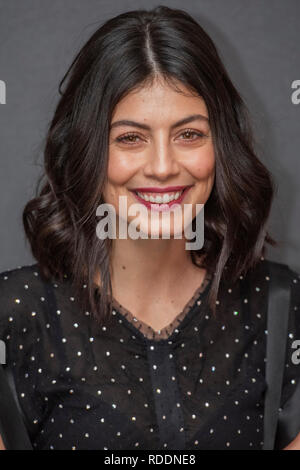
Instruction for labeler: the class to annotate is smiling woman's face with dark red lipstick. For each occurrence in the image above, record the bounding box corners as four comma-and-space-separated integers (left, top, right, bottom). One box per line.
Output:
103, 81, 215, 238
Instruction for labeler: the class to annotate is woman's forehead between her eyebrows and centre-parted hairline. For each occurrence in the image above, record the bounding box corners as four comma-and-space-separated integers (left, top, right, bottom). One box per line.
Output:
112, 80, 208, 123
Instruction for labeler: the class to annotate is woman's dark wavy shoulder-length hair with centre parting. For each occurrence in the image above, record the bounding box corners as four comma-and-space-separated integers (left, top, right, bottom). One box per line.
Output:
23, 6, 277, 322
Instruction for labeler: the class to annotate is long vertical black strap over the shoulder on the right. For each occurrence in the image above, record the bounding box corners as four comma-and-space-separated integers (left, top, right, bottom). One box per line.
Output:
263, 262, 291, 450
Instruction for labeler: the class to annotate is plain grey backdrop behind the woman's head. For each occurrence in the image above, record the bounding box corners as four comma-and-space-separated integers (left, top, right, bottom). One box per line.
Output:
0, 0, 300, 272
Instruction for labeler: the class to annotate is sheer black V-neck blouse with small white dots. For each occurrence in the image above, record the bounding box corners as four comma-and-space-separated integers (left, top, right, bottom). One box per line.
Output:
0, 260, 300, 450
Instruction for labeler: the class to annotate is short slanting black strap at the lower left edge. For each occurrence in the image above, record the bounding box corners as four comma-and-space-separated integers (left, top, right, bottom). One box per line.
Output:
0, 364, 32, 450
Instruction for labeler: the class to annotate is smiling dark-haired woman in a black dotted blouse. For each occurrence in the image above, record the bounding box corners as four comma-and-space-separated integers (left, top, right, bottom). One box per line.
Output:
0, 6, 300, 450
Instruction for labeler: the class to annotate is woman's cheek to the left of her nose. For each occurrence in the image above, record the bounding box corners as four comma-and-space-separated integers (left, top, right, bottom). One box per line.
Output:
107, 152, 136, 186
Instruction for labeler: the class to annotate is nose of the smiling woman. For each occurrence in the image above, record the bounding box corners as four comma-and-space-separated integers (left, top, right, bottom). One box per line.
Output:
144, 135, 180, 180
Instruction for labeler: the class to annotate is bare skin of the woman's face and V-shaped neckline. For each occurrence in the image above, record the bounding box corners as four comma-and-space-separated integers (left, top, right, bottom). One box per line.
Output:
102, 75, 215, 330
